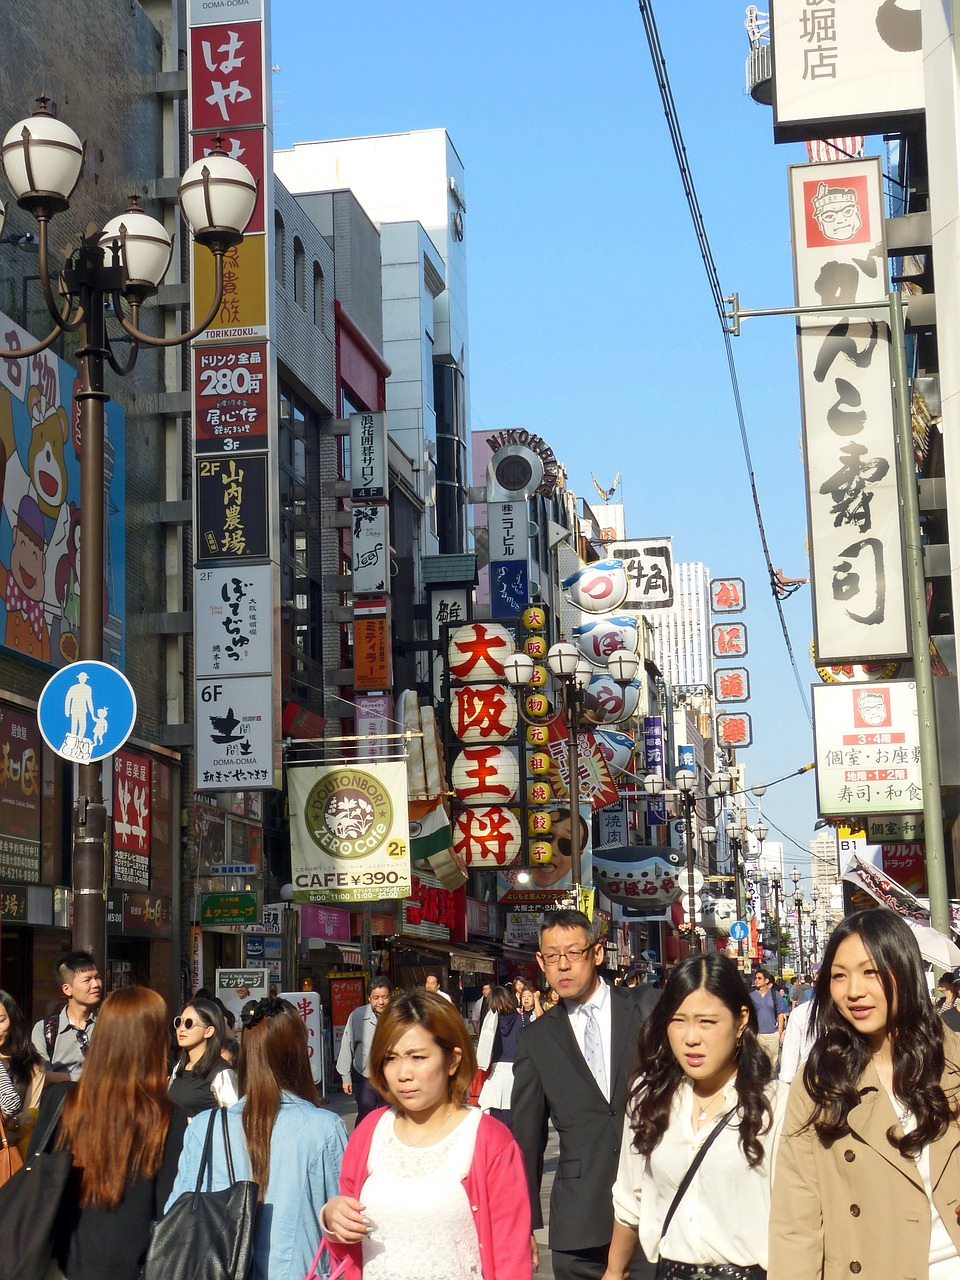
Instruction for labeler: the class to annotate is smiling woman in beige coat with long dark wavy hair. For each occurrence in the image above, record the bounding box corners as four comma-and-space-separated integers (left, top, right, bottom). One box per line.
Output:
769, 909, 960, 1280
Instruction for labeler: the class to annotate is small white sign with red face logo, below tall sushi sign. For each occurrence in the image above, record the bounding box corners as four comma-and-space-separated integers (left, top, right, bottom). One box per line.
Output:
813, 680, 923, 818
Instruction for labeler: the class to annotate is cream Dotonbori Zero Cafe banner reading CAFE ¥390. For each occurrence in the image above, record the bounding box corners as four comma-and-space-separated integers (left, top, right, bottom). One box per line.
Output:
287, 760, 410, 902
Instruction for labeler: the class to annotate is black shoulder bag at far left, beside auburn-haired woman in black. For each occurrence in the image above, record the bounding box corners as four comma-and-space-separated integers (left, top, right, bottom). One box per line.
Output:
0, 1091, 73, 1280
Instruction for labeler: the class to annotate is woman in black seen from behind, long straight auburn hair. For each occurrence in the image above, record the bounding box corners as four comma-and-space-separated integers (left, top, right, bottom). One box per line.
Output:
33, 987, 187, 1280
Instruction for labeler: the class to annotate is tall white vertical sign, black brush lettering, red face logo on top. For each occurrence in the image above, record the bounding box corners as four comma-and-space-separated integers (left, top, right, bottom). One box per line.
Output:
790, 157, 913, 666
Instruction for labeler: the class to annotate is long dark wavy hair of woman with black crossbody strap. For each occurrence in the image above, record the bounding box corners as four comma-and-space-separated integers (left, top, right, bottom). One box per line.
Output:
627, 955, 773, 1169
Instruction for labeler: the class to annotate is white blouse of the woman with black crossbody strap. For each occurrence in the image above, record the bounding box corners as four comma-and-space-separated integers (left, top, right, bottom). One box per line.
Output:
613, 1080, 788, 1270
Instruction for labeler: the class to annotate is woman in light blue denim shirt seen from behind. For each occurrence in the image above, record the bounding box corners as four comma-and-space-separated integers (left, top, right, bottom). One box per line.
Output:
167, 997, 347, 1280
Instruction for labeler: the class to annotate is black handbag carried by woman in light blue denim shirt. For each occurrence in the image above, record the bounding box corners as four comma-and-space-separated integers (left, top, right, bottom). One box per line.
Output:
142, 1107, 260, 1280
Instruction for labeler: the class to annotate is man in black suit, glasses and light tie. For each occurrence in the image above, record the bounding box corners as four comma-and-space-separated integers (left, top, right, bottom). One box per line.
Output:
511, 911, 659, 1280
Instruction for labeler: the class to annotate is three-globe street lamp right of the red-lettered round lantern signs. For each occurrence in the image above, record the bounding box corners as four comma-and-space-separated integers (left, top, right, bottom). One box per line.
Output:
503, 641, 640, 892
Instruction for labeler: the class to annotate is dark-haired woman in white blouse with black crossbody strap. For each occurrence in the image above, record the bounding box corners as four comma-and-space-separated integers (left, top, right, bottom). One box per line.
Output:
604, 954, 786, 1280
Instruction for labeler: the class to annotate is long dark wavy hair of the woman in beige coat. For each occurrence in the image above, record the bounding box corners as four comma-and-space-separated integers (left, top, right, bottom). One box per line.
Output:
804, 908, 960, 1158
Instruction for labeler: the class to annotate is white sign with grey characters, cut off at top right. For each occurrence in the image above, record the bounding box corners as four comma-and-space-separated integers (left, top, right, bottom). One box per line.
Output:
769, 0, 923, 142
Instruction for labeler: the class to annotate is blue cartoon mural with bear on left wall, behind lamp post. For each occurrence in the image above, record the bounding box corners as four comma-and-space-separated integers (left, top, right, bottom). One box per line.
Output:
0, 314, 125, 667
